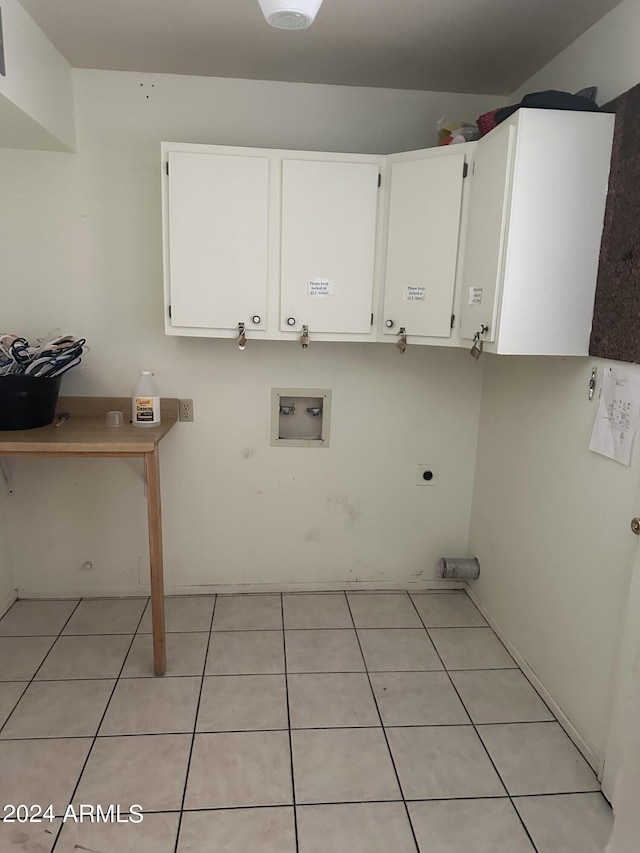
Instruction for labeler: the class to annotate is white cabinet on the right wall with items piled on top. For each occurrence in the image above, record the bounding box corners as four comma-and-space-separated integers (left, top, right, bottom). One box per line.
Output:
461, 109, 614, 355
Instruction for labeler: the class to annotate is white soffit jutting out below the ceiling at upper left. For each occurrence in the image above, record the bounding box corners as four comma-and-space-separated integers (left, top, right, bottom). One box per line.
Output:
0, 0, 75, 151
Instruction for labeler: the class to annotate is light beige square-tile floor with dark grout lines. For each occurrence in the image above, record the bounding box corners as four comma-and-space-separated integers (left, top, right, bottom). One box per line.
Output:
0, 592, 611, 853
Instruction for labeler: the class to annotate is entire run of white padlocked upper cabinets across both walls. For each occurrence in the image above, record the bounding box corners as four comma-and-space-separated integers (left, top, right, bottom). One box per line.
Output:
162, 115, 614, 355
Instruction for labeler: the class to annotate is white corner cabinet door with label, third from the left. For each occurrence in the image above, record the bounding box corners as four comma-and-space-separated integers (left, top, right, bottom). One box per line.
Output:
383, 154, 465, 337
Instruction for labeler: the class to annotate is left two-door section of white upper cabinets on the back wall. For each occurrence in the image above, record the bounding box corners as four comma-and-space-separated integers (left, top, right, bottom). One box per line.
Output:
162, 143, 384, 342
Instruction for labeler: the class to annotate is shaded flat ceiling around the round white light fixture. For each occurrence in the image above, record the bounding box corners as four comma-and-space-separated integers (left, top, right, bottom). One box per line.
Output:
20, 0, 620, 95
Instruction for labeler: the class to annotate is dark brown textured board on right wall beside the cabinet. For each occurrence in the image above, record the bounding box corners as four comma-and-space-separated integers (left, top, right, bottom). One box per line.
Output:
589, 85, 640, 363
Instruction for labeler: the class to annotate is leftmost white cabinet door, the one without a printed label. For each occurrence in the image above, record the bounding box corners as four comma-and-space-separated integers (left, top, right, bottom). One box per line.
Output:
168, 152, 269, 329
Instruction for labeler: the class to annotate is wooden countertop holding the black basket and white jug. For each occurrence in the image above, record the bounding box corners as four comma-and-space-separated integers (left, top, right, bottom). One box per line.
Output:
0, 397, 178, 456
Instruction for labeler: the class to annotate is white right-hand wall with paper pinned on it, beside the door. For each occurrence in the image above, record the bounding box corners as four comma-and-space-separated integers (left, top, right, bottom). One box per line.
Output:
470, 0, 640, 763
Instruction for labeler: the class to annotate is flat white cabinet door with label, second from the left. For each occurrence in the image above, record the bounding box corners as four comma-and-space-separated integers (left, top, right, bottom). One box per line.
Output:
280, 160, 378, 335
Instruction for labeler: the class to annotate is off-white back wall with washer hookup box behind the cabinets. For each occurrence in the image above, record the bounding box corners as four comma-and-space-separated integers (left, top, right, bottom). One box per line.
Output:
0, 71, 495, 595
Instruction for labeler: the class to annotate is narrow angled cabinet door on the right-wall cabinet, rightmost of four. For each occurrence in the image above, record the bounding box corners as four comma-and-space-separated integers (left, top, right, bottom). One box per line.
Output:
460, 127, 515, 341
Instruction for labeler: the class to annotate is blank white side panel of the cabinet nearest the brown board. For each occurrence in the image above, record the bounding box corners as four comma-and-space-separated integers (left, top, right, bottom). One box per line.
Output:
497, 110, 614, 355
